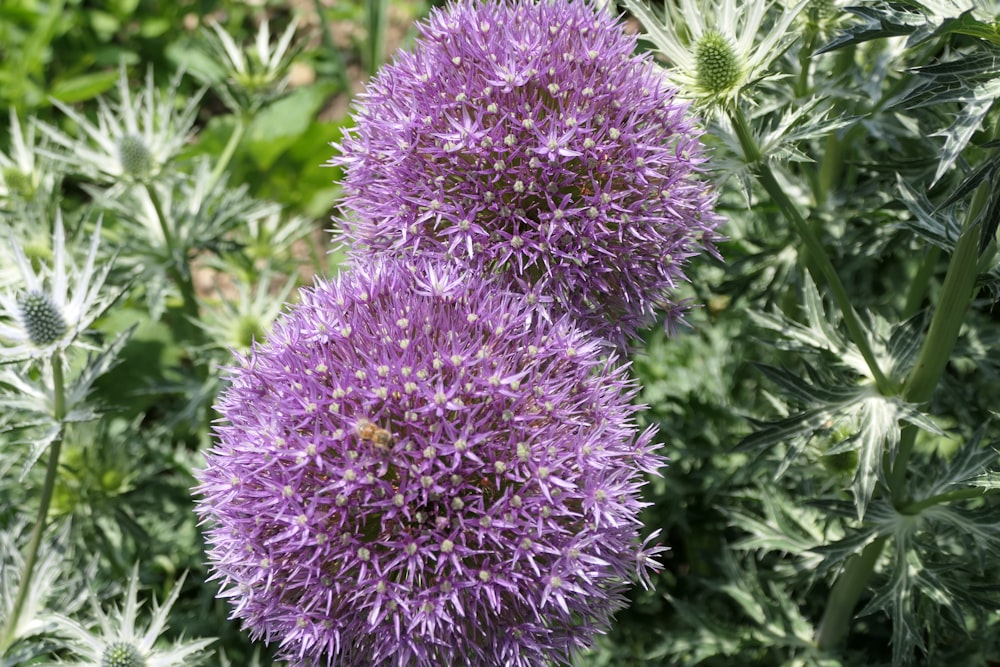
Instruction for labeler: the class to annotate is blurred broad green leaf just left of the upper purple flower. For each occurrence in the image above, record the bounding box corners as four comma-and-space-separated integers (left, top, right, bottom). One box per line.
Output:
245, 85, 334, 169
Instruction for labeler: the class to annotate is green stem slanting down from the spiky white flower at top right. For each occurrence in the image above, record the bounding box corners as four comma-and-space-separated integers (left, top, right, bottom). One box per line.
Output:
729, 105, 895, 396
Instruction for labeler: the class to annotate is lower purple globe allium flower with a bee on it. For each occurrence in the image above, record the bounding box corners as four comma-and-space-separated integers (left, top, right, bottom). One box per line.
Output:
198, 261, 662, 667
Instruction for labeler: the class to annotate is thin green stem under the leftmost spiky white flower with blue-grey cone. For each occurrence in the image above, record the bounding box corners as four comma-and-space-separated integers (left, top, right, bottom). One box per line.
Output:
0, 352, 66, 656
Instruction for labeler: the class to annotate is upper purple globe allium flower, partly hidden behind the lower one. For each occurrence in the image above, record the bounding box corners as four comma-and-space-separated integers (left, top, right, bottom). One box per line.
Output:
331, 0, 720, 343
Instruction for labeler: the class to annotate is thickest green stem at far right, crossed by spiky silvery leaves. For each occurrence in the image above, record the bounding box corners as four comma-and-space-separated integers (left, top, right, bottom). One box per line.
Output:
816, 177, 989, 650
